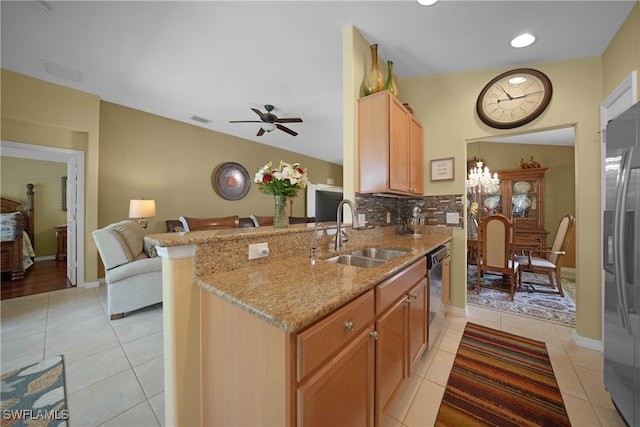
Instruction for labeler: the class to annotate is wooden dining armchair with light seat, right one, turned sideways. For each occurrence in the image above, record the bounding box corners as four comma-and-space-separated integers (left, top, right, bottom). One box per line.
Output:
516, 215, 576, 297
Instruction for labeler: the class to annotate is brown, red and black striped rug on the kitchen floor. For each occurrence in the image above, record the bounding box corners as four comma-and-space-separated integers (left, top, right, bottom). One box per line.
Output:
435, 322, 571, 427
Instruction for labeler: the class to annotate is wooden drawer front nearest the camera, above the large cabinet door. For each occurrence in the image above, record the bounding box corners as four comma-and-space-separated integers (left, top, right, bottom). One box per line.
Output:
296, 290, 375, 381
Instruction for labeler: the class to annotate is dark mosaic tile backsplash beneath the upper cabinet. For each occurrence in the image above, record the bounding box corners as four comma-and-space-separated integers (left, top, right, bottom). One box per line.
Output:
356, 193, 464, 227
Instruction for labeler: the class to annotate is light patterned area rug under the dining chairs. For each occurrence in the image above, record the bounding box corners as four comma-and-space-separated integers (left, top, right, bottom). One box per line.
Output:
467, 265, 576, 327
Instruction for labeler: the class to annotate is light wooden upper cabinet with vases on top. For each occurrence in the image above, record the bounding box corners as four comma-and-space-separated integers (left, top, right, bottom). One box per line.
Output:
358, 90, 423, 196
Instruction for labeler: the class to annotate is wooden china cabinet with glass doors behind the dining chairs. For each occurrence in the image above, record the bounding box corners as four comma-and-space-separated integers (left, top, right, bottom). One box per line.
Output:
468, 168, 549, 249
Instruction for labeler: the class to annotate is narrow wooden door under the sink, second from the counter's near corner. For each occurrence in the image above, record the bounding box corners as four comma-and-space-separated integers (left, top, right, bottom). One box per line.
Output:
376, 298, 408, 425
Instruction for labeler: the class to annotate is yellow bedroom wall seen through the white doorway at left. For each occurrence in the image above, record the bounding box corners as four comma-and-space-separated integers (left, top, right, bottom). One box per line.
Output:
0, 157, 67, 257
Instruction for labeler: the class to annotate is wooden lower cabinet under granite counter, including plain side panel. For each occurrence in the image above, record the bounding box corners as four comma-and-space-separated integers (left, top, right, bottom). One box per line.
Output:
201, 258, 429, 427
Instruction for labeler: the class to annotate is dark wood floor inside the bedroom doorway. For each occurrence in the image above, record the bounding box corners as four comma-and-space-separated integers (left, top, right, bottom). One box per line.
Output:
0, 260, 72, 300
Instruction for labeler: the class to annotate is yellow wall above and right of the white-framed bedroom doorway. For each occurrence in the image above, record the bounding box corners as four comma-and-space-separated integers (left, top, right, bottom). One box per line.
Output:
0, 69, 100, 282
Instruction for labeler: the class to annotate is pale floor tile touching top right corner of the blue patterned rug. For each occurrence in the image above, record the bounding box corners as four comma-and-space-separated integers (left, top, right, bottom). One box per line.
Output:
65, 346, 131, 393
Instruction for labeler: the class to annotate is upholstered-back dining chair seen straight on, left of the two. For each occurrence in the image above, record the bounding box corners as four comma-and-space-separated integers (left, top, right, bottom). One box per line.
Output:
476, 214, 519, 301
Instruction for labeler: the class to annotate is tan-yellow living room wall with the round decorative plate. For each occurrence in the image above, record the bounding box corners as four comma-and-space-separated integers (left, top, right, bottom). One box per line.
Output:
98, 102, 342, 233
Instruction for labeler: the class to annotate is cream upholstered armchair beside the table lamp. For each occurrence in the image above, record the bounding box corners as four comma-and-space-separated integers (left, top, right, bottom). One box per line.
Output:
92, 220, 162, 320
